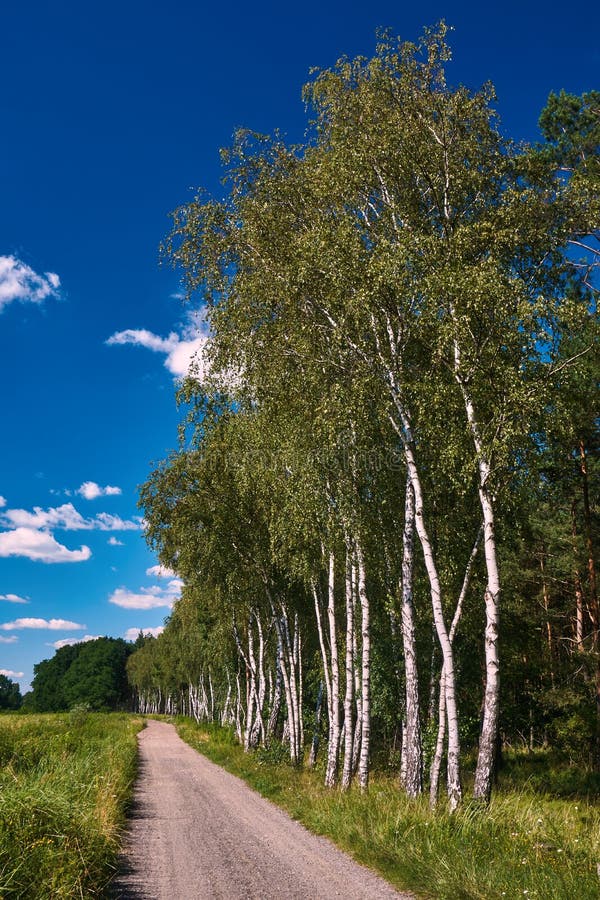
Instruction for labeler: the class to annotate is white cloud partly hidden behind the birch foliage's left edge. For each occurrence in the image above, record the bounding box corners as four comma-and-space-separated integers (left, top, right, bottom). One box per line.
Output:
106, 317, 208, 381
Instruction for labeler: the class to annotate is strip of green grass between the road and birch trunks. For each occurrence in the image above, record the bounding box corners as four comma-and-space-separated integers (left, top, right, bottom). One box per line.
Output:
177, 719, 600, 900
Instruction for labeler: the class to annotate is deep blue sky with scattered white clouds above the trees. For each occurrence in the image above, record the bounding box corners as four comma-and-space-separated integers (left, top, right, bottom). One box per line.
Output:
0, 0, 600, 689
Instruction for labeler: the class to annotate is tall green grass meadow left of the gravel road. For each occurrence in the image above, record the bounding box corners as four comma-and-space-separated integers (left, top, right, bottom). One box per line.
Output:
0, 710, 143, 900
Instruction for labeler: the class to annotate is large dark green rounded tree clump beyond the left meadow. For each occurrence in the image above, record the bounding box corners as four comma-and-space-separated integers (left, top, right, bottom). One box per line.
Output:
25, 637, 134, 712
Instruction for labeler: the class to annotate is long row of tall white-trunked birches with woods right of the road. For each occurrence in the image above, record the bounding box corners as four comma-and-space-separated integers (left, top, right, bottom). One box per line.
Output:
129, 25, 600, 808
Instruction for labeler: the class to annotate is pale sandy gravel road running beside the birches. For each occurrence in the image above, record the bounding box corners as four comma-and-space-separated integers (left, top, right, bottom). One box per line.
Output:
113, 720, 409, 900
